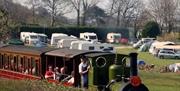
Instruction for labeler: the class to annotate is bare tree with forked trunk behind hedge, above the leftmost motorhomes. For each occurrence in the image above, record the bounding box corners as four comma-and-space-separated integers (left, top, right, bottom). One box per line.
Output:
43, 0, 71, 27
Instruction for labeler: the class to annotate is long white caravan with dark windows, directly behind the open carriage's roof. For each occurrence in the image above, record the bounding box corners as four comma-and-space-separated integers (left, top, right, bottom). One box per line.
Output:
70, 40, 115, 52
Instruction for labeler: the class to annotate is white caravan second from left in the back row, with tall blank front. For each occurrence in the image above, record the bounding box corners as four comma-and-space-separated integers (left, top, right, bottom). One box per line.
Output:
51, 33, 76, 46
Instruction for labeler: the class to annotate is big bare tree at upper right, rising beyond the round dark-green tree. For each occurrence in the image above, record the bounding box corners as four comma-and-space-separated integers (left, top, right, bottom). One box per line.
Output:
148, 0, 178, 32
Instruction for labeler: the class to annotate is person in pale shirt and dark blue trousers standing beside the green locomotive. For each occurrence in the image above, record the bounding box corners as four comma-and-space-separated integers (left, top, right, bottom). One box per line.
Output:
79, 58, 90, 89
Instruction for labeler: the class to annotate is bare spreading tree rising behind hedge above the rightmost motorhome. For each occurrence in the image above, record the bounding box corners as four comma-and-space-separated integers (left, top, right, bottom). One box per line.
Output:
109, 0, 141, 27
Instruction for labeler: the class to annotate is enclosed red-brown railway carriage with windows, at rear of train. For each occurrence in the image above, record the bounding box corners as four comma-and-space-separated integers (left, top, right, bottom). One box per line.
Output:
0, 45, 54, 79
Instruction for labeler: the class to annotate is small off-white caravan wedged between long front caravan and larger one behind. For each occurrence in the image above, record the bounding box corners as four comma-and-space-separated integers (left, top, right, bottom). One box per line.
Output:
57, 38, 78, 48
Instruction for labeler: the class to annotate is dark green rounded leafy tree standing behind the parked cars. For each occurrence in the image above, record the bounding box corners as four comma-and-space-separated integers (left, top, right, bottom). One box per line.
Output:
142, 21, 160, 37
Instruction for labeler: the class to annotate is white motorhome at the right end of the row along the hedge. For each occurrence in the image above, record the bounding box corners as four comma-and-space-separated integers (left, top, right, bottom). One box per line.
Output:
107, 33, 121, 43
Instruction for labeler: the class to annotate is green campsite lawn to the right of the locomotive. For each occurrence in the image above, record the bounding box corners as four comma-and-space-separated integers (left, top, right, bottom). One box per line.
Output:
116, 48, 180, 91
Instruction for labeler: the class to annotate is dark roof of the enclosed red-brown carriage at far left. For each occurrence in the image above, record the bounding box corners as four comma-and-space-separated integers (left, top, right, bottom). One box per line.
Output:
0, 45, 55, 56
